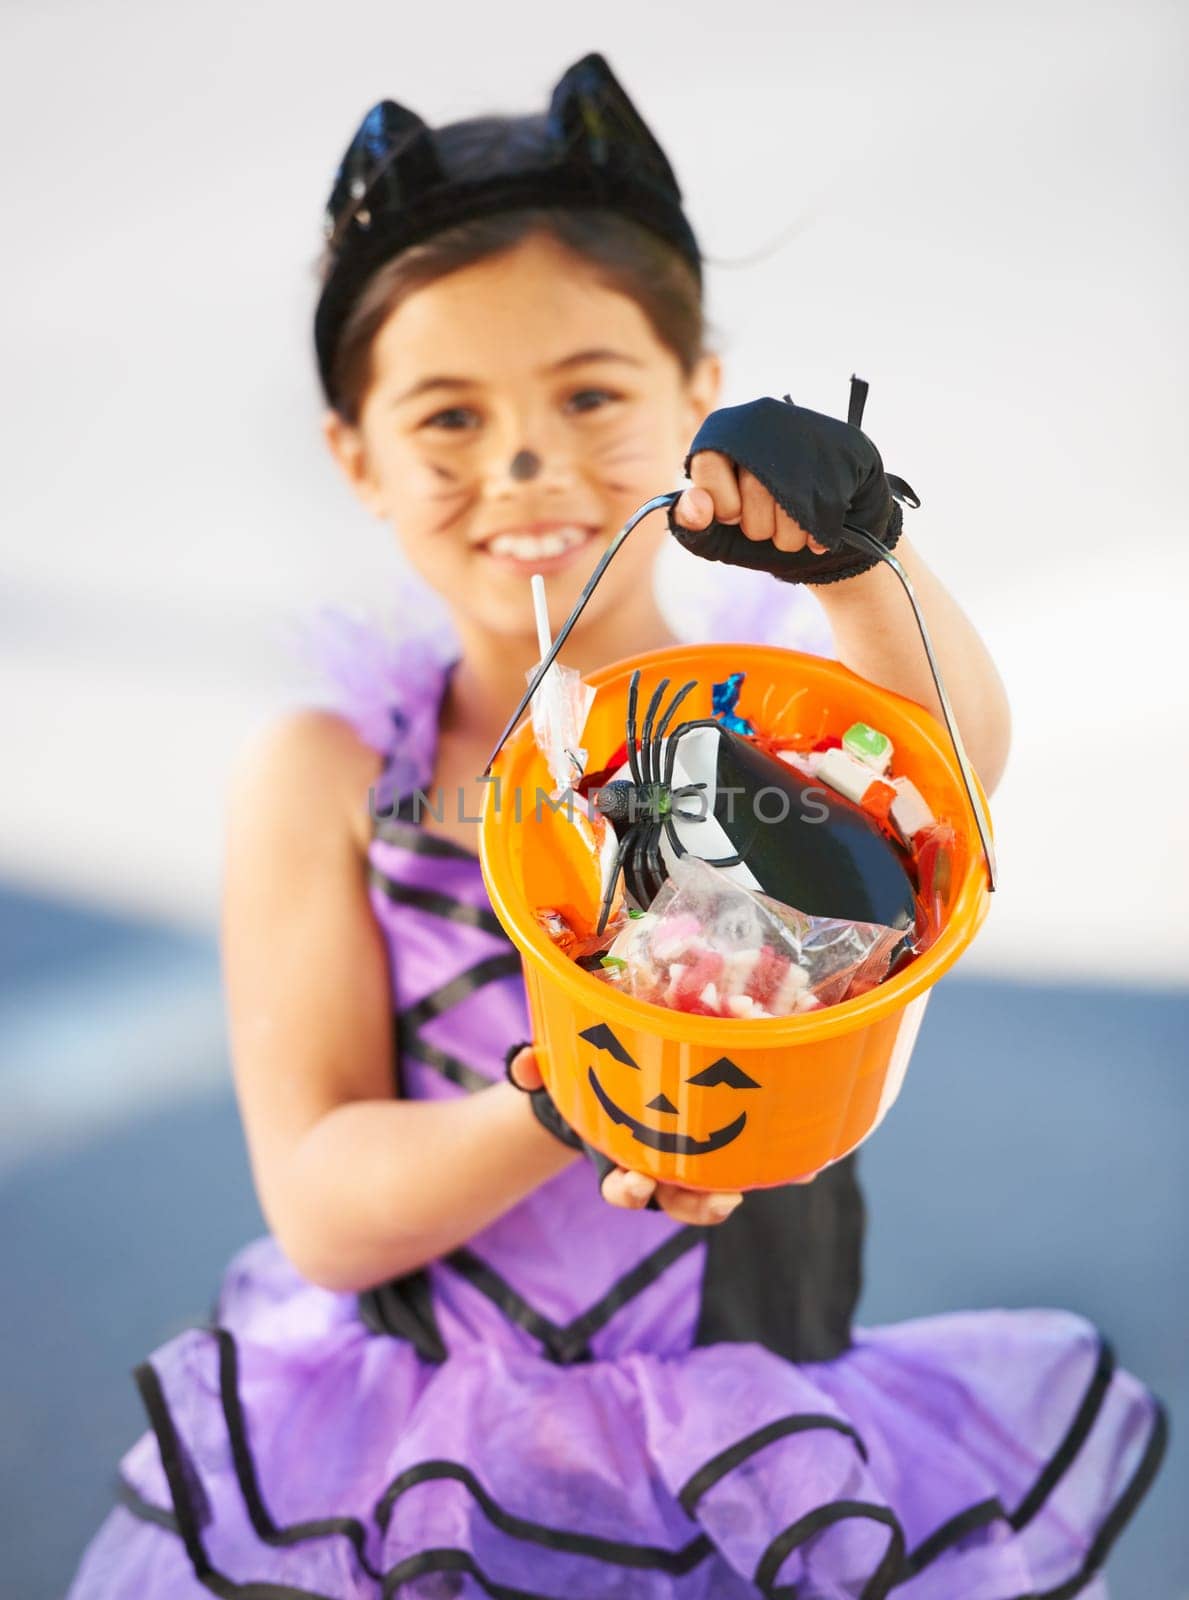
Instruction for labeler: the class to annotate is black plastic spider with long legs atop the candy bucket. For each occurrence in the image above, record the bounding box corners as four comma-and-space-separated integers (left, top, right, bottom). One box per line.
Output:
595, 670, 743, 933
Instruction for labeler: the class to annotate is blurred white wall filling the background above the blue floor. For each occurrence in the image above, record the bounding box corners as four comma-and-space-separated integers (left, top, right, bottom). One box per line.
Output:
0, 0, 1189, 981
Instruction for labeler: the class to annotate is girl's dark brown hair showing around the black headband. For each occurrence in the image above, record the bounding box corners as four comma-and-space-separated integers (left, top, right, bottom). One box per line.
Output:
318, 117, 706, 426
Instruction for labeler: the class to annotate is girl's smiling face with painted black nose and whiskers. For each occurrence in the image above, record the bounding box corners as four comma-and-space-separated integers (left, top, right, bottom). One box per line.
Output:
325, 235, 719, 635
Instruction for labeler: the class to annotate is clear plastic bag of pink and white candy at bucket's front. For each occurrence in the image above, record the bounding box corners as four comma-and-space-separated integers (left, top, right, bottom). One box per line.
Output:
603, 856, 906, 1019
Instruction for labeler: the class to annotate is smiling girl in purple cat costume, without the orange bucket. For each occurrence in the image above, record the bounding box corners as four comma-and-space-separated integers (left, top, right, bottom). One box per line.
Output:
72, 56, 1162, 1600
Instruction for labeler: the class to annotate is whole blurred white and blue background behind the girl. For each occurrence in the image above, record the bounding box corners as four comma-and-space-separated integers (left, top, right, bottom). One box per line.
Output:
0, 0, 1189, 1600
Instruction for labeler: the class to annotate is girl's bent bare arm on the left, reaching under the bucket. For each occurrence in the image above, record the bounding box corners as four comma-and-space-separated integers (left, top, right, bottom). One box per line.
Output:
222, 710, 576, 1290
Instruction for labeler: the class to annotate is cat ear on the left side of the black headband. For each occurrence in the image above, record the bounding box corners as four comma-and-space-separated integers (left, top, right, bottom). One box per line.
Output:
322, 101, 442, 240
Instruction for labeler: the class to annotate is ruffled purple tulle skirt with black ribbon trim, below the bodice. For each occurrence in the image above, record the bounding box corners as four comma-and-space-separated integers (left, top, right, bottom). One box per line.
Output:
70, 1238, 1163, 1600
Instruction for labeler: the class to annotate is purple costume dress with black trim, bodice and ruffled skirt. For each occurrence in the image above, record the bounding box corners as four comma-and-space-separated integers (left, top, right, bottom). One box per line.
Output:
70, 572, 1165, 1600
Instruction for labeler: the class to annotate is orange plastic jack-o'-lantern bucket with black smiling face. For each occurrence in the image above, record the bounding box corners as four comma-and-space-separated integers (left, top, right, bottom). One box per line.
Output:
480, 643, 994, 1190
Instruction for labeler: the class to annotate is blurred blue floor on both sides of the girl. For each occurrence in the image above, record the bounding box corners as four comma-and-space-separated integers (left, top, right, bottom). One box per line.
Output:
0, 891, 1189, 1600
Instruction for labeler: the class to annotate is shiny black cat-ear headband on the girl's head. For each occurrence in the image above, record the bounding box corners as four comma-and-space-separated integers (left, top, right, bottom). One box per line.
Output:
314, 54, 701, 405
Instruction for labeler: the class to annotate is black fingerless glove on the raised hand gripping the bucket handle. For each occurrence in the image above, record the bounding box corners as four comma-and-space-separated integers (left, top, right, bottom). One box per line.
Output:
669, 378, 920, 584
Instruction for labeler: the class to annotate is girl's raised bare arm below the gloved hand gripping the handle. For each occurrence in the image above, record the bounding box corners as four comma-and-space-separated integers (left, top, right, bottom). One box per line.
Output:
812, 537, 1011, 794
